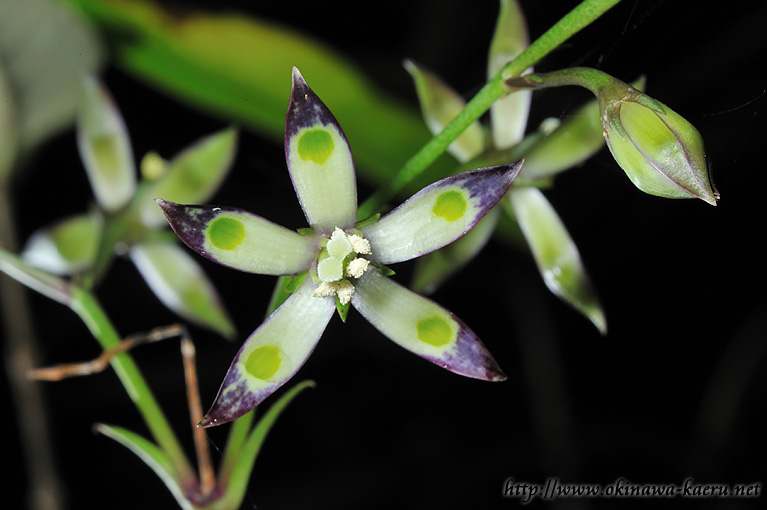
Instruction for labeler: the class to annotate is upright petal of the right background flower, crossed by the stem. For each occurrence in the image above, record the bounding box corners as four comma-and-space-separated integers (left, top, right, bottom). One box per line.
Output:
487, 0, 532, 149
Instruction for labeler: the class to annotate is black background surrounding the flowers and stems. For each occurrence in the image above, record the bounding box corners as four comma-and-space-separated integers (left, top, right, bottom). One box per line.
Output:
2, 0, 767, 509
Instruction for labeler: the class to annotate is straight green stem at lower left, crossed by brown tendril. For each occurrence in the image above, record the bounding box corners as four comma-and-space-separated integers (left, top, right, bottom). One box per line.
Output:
69, 286, 195, 480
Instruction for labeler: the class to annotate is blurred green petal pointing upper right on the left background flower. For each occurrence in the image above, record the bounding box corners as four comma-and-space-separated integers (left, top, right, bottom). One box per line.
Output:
140, 128, 237, 228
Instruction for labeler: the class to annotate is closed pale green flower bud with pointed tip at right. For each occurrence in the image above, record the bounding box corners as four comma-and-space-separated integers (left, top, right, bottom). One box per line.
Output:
598, 80, 719, 205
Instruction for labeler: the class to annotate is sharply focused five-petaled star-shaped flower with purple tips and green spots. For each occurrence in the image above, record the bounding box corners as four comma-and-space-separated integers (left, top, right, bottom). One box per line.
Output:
157, 68, 521, 427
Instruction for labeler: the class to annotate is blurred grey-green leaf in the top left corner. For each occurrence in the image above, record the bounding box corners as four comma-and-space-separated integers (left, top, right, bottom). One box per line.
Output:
0, 0, 102, 155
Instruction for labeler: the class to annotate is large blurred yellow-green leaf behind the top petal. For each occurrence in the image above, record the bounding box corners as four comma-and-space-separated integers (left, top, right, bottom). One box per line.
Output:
69, 0, 450, 192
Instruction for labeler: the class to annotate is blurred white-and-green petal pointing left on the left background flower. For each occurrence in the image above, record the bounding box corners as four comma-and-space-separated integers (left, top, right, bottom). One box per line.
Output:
21, 214, 103, 275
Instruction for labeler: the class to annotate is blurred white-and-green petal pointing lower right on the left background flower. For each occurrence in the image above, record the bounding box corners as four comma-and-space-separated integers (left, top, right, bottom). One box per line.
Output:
130, 241, 235, 338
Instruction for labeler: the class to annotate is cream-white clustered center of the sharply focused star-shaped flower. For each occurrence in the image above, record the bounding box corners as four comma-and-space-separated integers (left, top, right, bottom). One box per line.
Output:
314, 227, 371, 305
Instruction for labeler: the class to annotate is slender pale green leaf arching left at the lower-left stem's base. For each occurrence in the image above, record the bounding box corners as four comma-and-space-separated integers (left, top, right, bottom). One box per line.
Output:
95, 424, 194, 510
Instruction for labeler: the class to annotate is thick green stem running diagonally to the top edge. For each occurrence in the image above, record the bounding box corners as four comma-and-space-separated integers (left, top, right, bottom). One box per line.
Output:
358, 0, 620, 219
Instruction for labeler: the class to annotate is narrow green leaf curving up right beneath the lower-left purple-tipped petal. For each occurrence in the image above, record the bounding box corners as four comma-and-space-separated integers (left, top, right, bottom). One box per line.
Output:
213, 381, 314, 508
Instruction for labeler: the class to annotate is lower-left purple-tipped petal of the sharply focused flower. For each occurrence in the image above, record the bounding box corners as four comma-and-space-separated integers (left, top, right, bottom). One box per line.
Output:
200, 278, 336, 427
